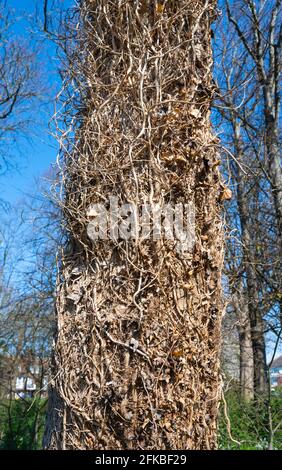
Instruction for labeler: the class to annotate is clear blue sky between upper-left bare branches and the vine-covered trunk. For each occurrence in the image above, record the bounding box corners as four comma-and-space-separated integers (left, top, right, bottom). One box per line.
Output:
0, 0, 74, 204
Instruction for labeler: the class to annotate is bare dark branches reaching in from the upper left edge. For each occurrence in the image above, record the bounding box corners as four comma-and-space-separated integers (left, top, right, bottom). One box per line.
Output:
0, 0, 46, 175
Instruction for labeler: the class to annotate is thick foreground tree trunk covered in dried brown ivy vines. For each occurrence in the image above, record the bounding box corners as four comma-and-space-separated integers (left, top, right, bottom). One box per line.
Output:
44, 0, 226, 449
